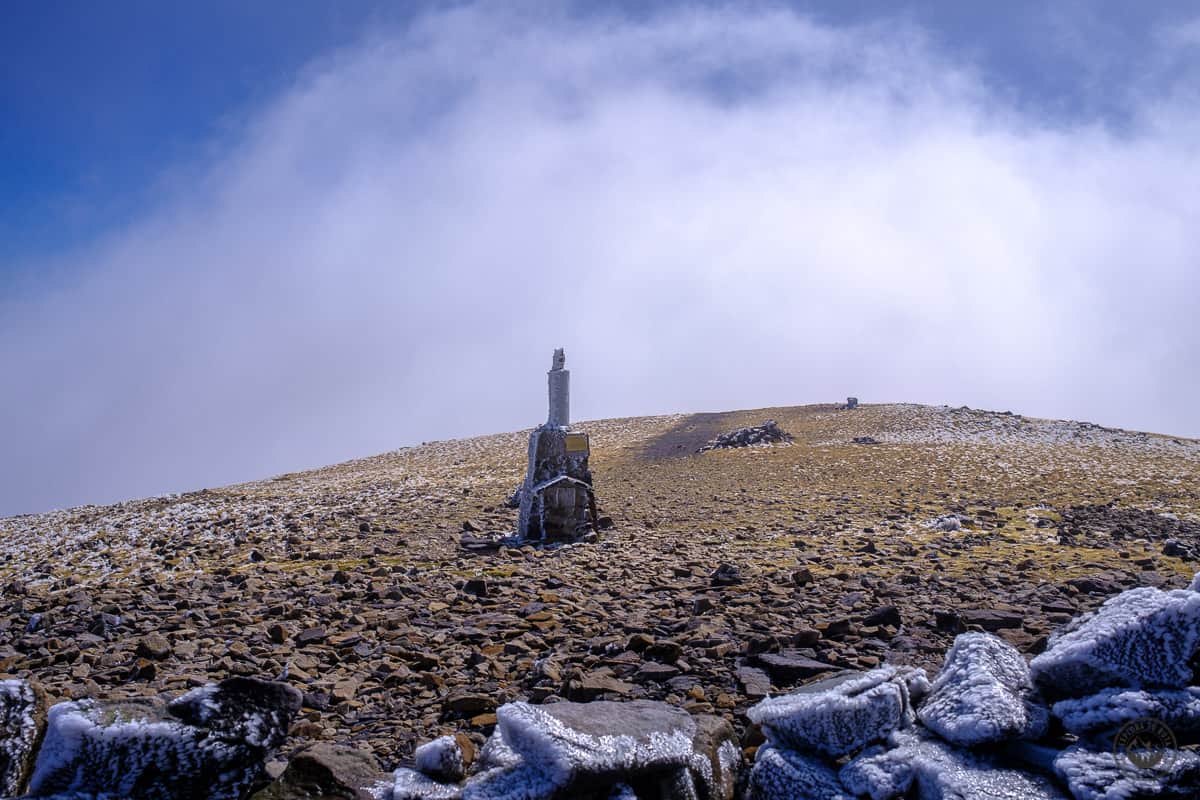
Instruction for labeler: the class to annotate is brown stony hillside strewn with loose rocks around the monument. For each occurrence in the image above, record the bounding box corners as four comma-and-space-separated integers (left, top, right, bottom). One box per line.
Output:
0, 405, 1200, 768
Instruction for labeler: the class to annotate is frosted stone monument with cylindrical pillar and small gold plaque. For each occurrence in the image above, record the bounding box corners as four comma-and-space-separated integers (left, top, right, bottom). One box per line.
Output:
517, 349, 596, 542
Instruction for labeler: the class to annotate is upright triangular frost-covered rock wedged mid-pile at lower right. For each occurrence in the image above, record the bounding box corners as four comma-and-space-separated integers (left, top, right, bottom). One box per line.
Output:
917, 633, 1049, 747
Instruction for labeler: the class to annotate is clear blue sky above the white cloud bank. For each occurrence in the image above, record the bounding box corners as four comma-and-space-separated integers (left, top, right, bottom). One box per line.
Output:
0, 0, 1195, 273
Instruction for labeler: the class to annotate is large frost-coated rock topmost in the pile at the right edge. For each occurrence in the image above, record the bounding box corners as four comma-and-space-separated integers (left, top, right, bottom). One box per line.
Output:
1030, 588, 1200, 698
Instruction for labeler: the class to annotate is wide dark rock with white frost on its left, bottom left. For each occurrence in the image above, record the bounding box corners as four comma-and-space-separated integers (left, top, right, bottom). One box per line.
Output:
29, 679, 301, 800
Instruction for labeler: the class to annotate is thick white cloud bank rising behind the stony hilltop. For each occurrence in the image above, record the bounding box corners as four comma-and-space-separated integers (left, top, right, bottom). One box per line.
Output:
0, 8, 1200, 513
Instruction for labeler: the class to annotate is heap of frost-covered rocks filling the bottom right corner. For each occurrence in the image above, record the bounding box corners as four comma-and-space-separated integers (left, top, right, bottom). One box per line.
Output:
748, 576, 1200, 800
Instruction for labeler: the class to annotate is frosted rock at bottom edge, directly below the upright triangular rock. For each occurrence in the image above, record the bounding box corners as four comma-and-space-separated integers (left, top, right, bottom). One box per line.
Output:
839, 732, 1066, 800
